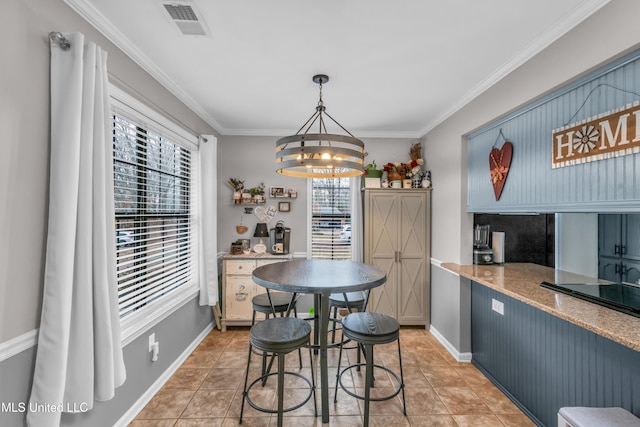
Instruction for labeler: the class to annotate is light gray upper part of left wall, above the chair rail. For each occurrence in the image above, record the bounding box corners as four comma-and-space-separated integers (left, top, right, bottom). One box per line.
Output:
0, 0, 215, 343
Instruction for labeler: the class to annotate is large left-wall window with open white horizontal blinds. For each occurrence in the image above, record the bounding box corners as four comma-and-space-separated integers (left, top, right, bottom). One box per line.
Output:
111, 112, 195, 318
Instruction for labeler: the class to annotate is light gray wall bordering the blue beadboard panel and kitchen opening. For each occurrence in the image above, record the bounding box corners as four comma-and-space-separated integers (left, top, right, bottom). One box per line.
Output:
424, 0, 640, 264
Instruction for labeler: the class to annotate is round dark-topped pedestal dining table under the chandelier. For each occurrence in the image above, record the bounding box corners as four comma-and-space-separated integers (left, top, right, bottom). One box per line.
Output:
253, 259, 387, 423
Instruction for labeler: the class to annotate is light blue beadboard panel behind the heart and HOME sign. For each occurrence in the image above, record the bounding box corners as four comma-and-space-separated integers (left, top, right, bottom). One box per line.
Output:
467, 52, 640, 213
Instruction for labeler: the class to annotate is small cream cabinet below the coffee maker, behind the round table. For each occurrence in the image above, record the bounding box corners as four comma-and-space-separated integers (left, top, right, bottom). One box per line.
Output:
222, 253, 292, 331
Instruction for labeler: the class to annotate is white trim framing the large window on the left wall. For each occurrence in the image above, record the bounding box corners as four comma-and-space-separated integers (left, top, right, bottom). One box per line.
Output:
105, 84, 200, 347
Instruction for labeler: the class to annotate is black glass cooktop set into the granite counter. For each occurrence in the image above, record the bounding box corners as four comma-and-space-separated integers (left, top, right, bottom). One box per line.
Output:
540, 282, 640, 317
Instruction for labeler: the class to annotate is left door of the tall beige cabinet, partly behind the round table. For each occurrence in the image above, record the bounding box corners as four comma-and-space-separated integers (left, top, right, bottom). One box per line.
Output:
365, 191, 398, 318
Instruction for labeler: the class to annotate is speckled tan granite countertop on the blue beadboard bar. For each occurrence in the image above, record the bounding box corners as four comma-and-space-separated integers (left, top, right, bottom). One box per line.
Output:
441, 263, 640, 351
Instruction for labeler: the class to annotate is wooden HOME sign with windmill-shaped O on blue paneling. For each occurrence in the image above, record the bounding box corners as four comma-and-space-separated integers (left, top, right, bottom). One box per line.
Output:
551, 101, 640, 169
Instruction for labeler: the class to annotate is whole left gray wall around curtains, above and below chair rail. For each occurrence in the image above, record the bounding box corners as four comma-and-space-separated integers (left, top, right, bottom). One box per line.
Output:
0, 0, 215, 426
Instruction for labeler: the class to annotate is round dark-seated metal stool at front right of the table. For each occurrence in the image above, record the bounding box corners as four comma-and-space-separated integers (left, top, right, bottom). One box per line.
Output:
334, 312, 407, 427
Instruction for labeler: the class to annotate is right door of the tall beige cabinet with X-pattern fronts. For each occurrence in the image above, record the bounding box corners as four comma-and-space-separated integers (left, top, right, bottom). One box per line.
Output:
397, 193, 429, 324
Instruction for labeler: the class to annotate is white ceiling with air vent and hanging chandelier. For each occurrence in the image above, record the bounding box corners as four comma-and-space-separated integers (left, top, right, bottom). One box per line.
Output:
65, 0, 608, 138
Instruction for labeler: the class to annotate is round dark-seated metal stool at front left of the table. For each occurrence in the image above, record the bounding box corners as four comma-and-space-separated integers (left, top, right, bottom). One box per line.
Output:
239, 317, 318, 427
